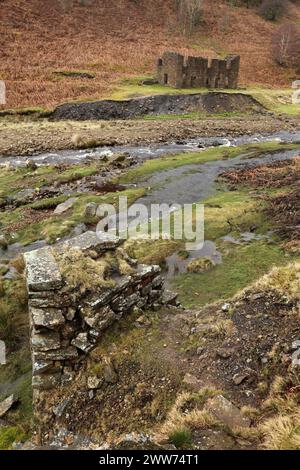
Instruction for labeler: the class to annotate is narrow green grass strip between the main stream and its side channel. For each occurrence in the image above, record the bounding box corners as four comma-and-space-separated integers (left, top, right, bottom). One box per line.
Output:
119, 142, 300, 183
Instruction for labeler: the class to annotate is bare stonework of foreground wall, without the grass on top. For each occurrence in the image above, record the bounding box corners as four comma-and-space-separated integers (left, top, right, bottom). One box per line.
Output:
25, 232, 171, 392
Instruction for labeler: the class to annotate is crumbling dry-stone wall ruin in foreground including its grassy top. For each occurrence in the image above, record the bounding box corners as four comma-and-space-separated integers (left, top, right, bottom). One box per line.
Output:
25, 232, 176, 438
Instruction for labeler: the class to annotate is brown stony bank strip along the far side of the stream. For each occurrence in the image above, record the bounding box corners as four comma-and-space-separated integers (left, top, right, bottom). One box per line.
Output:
0, 115, 300, 156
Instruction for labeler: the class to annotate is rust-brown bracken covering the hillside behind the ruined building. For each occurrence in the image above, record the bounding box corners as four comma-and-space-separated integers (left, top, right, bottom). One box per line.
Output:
0, 0, 300, 108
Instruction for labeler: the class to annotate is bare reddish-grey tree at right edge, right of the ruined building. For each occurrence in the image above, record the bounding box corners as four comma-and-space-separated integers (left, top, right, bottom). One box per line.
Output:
272, 23, 300, 66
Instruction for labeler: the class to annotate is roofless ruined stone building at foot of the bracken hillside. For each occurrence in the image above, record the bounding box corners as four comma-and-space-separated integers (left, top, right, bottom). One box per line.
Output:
157, 52, 240, 89
